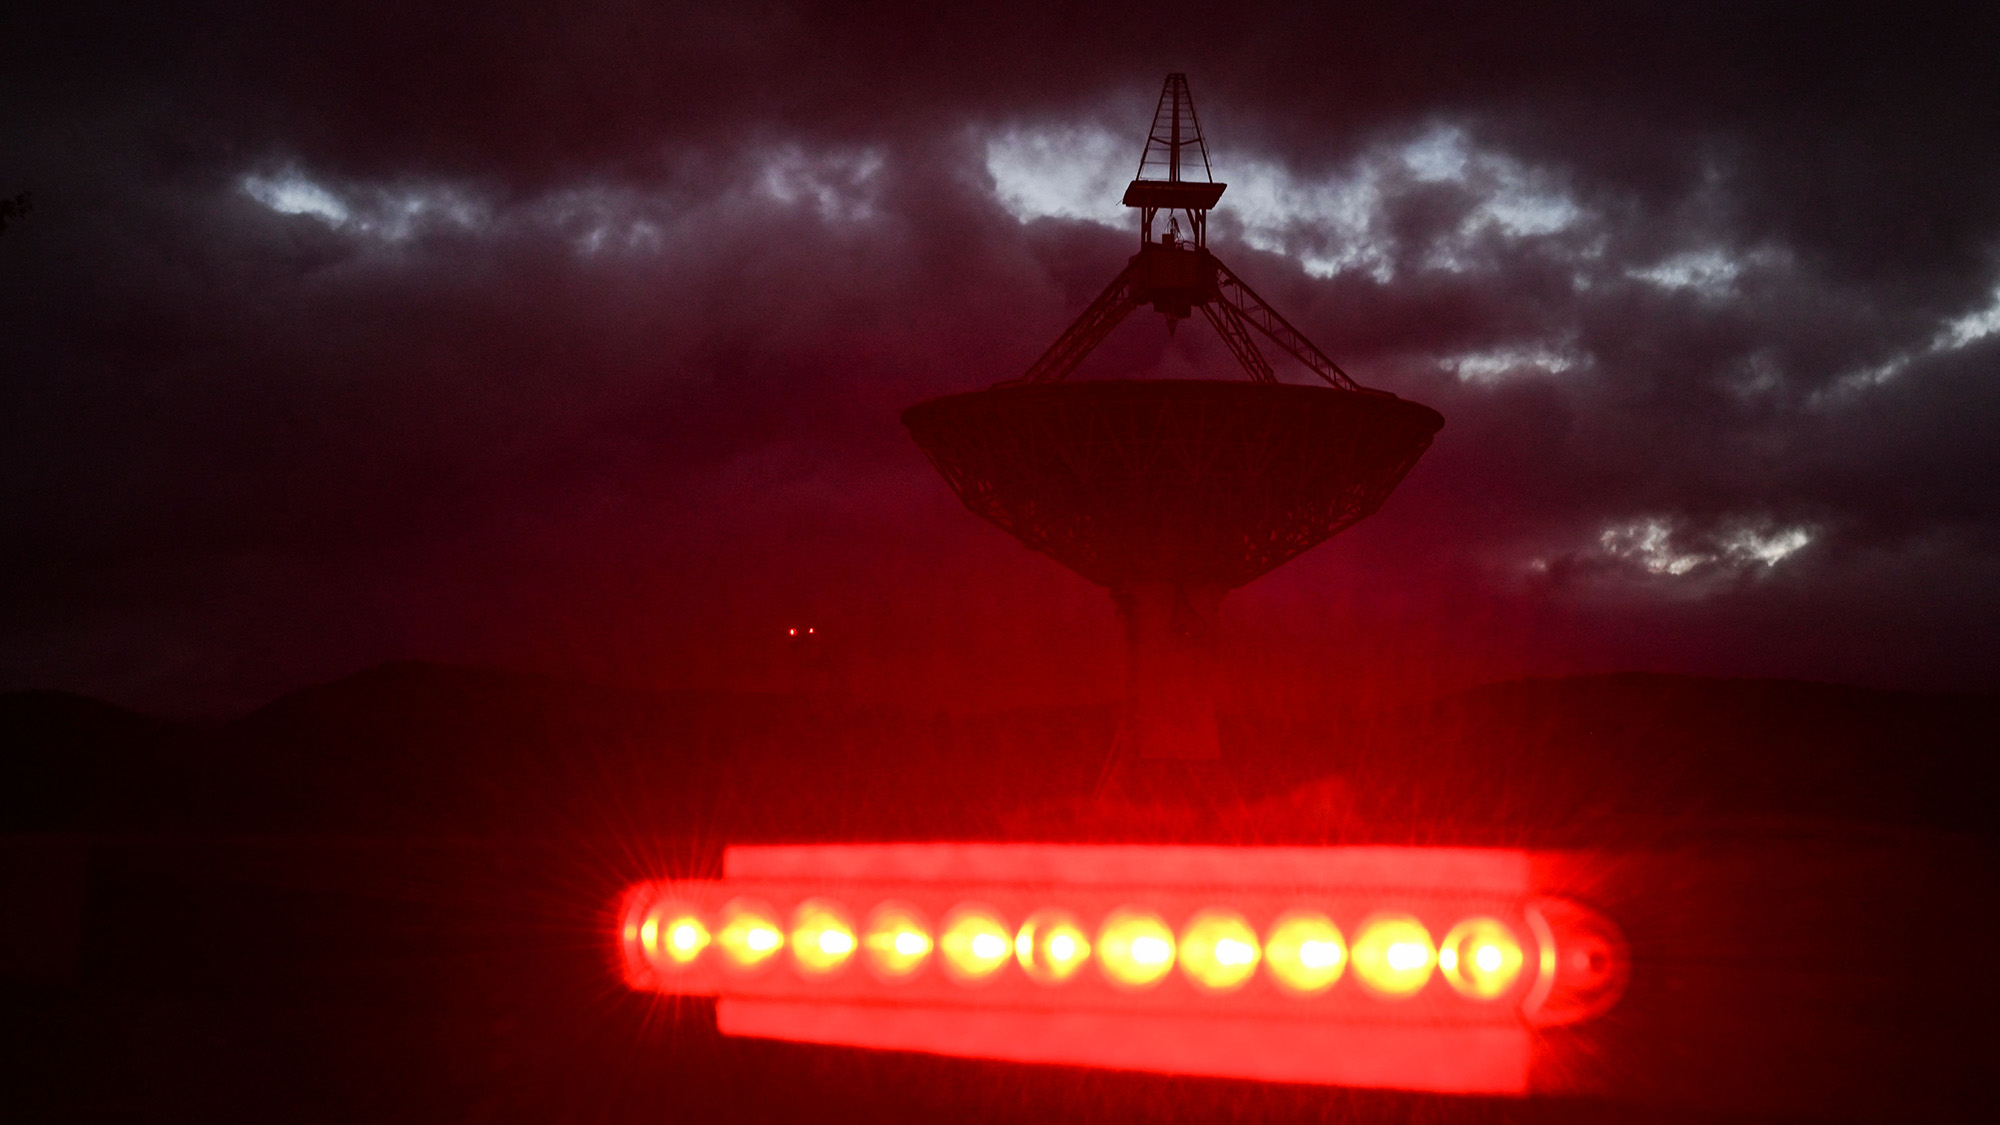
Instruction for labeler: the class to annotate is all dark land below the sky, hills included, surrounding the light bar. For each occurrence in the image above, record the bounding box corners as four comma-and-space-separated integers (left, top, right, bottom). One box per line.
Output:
0, 665, 2000, 1121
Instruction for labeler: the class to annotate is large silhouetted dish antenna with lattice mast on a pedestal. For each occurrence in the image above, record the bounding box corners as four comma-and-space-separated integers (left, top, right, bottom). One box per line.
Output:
902, 74, 1444, 757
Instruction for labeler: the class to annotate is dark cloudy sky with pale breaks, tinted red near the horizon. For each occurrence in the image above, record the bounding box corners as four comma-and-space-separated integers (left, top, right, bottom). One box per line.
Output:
0, 0, 2000, 713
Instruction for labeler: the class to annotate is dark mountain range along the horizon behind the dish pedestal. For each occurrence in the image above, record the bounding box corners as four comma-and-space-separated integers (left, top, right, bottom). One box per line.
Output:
0, 663, 2000, 845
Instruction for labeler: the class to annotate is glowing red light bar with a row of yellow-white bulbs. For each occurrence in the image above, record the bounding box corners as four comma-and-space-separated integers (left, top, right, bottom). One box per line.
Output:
620, 843, 1626, 1093
